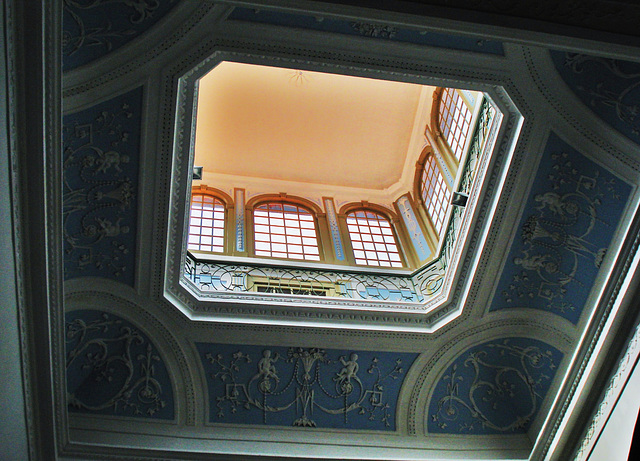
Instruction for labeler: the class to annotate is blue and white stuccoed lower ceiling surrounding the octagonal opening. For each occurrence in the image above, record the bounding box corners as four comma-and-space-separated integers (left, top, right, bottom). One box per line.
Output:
32, 0, 640, 460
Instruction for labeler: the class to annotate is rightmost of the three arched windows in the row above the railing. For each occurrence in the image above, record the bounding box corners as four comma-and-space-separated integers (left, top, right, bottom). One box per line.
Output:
347, 210, 402, 267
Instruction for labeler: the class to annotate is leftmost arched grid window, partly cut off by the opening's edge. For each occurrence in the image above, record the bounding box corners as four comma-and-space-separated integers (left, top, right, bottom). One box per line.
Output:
187, 194, 225, 253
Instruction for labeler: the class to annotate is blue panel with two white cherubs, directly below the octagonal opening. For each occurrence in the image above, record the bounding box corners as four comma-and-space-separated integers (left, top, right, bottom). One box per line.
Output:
197, 344, 418, 430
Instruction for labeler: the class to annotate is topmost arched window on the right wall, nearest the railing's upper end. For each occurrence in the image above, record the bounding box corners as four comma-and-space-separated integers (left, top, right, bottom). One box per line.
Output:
440, 88, 471, 161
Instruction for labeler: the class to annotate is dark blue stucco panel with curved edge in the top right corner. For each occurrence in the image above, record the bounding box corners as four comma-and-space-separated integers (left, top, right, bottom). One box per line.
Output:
551, 51, 640, 143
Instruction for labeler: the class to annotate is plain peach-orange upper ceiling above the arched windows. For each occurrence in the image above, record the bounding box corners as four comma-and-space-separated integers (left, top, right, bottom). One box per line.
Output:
195, 62, 433, 190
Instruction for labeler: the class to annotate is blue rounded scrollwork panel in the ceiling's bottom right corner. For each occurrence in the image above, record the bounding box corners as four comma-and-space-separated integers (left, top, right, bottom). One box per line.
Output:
427, 338, 563, 434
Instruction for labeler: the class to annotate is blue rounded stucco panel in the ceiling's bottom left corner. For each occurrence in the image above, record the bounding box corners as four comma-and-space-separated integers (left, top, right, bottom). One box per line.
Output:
65, 310, 174, 419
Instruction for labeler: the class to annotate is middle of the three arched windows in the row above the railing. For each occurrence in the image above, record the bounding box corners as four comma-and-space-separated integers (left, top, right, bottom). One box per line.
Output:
253, 202, 320, 261
